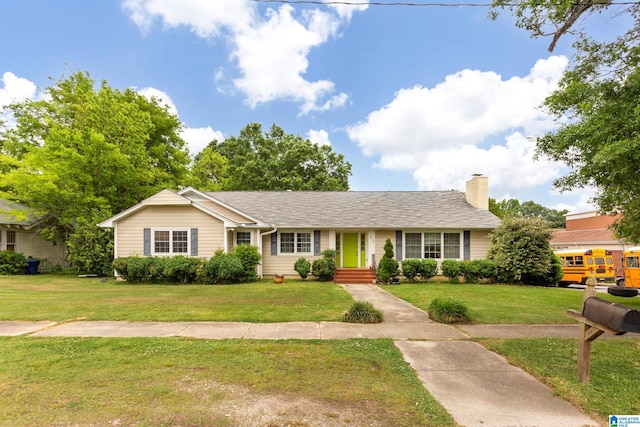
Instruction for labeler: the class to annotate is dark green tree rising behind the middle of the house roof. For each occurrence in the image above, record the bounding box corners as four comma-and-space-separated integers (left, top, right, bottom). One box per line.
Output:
205, 123, 351, 191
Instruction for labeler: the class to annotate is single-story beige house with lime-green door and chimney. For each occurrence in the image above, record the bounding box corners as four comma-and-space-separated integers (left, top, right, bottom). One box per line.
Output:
99, 176, 500, 277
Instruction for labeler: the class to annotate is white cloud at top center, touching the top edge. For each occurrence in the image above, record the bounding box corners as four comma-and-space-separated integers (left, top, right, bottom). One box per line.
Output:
123, 0, 367, 114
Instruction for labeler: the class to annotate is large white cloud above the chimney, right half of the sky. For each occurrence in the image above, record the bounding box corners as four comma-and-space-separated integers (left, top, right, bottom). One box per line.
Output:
347, 56, 567, 196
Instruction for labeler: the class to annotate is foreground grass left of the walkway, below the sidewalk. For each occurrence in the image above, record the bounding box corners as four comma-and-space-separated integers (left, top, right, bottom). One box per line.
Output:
0, 337, 456, 427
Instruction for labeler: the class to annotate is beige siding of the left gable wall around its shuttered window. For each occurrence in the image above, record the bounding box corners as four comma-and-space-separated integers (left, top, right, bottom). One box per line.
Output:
116, 206, 224, 258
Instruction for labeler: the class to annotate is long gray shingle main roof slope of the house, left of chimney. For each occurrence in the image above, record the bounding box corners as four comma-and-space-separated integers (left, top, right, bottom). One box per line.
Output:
207, 191, 500, 229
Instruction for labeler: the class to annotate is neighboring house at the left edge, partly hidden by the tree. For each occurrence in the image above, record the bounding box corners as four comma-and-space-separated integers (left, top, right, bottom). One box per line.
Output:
0, 199, 66, 271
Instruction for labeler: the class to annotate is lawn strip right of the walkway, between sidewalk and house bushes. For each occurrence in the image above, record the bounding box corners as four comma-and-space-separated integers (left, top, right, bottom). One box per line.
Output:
384, 283, 640, 324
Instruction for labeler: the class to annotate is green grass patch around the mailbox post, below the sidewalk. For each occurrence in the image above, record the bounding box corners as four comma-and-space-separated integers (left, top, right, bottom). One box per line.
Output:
479, 338, 640, 424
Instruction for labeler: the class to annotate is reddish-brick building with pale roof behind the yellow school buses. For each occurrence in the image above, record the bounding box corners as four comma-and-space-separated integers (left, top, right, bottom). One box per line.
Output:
551, 211, 629, 276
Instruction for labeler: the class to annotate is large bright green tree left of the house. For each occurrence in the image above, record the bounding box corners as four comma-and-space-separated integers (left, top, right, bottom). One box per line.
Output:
0, 72, 189, 225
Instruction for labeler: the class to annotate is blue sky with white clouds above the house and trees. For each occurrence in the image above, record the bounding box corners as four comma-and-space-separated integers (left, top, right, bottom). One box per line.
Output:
0, 0, 622, 211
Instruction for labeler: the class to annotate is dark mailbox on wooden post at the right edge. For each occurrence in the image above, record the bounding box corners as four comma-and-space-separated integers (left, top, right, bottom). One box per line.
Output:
582, 297, 640, 332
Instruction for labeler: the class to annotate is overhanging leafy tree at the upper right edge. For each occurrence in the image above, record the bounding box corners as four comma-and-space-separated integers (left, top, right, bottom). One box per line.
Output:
494, 0, 640, 242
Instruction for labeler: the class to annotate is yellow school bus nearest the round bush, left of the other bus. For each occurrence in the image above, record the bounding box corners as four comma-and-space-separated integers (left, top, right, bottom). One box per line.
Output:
555, 248, 616, 286
